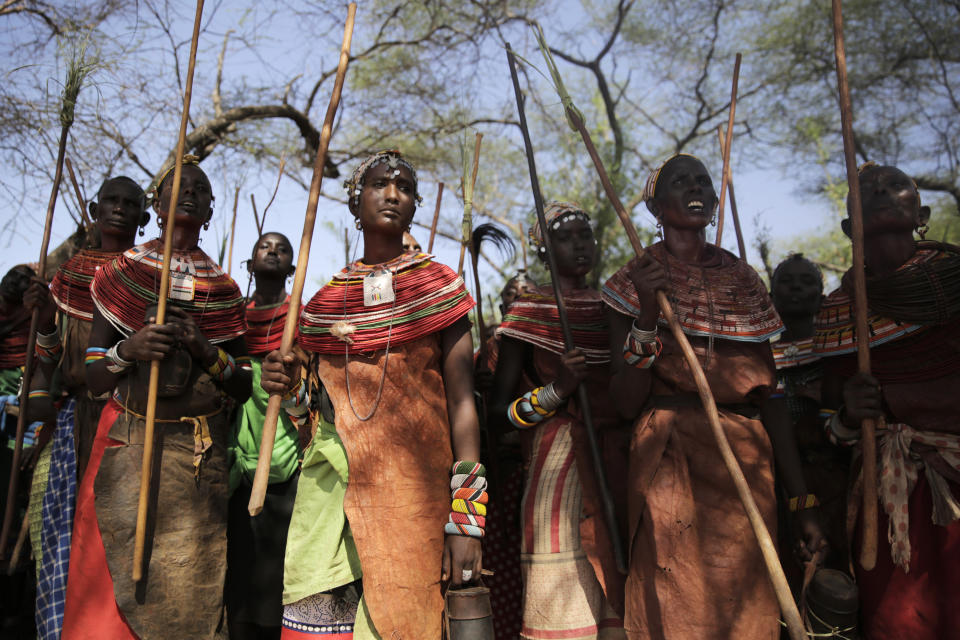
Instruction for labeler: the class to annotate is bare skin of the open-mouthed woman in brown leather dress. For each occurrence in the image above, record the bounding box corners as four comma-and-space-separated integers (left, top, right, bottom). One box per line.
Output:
608, 156, 826, 562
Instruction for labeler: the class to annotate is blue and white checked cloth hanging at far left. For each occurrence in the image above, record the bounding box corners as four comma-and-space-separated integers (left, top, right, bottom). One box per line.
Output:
35, 398, 77, 640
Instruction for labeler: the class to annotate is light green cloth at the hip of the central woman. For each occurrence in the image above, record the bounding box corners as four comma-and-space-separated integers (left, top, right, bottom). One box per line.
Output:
283, 419, 366, 604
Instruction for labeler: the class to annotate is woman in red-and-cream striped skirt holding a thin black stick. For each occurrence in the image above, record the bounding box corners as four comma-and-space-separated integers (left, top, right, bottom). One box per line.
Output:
491, 202, 628, 640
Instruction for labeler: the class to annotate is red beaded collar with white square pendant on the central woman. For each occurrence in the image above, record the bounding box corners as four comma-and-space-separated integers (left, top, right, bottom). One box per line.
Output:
299, 253, 473, 355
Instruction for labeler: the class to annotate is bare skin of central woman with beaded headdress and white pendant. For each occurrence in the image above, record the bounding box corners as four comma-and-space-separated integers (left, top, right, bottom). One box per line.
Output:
260, 164, 481, 586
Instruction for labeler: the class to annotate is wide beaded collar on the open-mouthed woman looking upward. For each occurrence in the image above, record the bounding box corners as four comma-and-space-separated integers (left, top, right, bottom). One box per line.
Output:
601, 242, 783, 342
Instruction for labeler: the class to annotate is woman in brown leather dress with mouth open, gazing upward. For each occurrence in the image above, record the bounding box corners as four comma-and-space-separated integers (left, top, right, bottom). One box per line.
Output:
602, 154, 822, 639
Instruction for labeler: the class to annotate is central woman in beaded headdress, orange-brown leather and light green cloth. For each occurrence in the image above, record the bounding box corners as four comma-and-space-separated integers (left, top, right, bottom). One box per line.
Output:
261, 151, 487, 638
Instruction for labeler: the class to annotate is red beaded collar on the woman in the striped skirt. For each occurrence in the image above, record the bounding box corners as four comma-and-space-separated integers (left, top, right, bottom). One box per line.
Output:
497, 286, 610, 364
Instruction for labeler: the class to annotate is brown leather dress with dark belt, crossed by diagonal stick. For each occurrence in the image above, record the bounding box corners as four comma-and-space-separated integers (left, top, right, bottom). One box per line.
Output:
625, 333, 780, 640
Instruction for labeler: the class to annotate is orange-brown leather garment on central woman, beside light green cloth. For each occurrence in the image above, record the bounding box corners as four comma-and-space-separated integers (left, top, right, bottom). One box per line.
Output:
318, 333, 453, 640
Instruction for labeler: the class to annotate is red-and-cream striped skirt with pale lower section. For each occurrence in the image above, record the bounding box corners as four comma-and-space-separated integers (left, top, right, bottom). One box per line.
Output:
520, 416, 626, 640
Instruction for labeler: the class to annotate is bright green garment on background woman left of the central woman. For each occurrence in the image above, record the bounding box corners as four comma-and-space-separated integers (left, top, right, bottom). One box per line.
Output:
229, 358, 300, 493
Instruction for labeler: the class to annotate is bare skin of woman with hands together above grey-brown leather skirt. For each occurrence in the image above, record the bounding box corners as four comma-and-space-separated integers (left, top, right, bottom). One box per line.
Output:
87, 165, 251, 417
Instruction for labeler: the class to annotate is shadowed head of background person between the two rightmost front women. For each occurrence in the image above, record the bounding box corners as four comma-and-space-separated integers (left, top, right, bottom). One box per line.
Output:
770, 258, 823, 341
